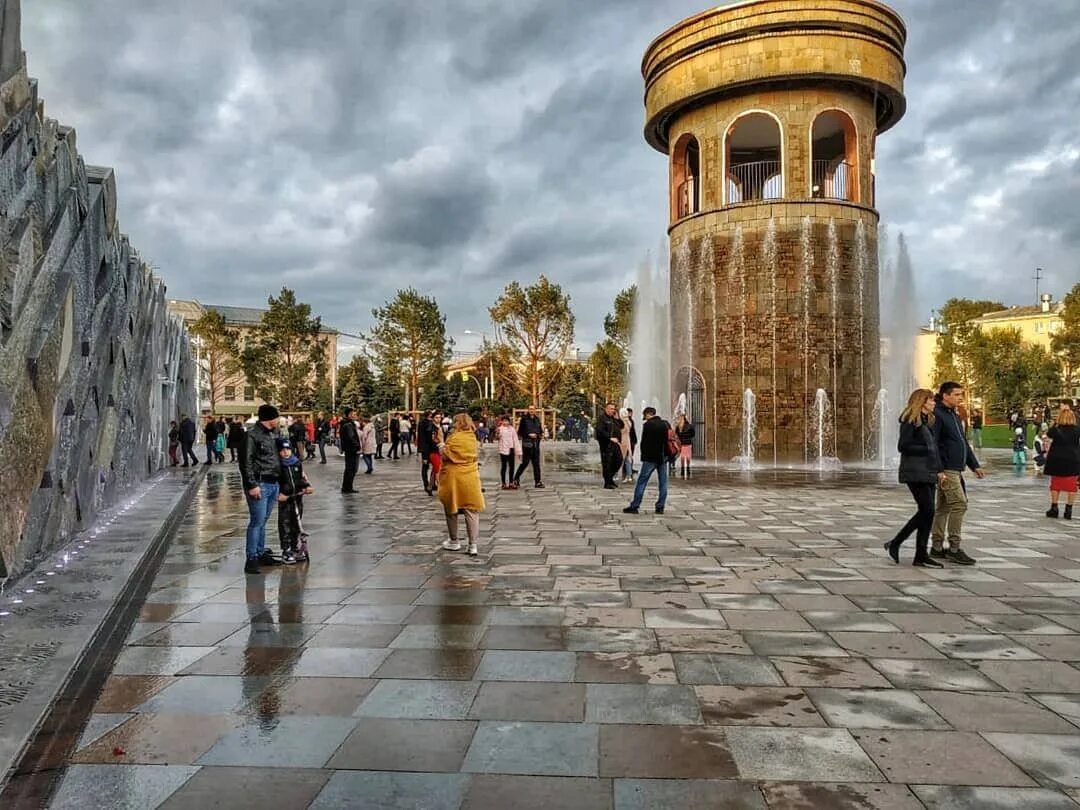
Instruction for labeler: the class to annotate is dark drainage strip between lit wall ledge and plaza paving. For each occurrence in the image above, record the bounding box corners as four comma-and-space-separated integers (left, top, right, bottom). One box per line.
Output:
0, 475, 204, 810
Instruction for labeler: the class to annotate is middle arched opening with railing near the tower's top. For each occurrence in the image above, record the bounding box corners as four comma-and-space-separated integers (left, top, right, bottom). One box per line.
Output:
724, 112, 784, 205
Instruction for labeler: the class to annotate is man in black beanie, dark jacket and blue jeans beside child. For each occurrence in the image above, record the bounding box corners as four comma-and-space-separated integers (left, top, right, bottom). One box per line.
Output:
240, 405, 281, 573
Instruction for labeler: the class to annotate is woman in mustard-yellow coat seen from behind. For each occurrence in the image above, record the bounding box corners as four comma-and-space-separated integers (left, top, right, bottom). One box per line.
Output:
438, 414, 484, 556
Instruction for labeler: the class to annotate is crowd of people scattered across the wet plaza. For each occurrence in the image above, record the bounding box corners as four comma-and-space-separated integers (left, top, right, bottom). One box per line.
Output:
168, 382, 1080, 573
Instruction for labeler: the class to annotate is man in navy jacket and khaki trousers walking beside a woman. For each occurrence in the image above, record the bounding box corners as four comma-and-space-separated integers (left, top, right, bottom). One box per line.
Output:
930, 382, 985, 565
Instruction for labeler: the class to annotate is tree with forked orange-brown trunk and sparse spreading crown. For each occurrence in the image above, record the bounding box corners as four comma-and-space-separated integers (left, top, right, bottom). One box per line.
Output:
488, 275, 575, 406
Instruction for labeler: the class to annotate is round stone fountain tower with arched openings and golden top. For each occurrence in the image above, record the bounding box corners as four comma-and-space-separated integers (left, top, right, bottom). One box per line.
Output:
642, 0, 907, 462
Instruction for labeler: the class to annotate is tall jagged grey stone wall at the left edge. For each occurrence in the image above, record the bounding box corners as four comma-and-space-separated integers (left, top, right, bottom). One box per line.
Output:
0, 0, 195, 577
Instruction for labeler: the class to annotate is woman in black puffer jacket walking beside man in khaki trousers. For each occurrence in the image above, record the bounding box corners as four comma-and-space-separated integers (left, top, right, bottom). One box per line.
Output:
885, 388, 943, 568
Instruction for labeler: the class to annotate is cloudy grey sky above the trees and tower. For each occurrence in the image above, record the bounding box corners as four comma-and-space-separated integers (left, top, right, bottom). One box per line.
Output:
23, 0, 1080, 356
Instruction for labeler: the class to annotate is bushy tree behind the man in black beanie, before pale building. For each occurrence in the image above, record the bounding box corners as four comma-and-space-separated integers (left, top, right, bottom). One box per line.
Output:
240, 287, 329, 410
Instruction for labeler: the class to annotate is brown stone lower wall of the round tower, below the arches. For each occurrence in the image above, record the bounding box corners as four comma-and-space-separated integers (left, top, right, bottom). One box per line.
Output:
671, 202, 880, 462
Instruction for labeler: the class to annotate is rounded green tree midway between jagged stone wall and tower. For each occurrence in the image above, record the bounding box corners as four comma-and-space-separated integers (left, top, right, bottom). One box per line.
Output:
368, 287, 451, 410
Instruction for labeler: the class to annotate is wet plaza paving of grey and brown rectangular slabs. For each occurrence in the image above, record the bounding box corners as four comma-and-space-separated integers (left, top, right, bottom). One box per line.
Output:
25, 445, 1080, 810
